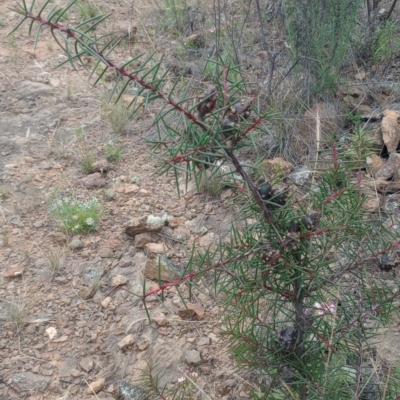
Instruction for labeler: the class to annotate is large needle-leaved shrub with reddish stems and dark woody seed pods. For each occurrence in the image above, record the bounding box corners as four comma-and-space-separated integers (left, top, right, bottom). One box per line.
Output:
10, 0, 400, 400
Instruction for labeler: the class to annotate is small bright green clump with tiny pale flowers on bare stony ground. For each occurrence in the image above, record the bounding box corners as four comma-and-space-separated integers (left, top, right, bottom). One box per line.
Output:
50, 196, 100, 233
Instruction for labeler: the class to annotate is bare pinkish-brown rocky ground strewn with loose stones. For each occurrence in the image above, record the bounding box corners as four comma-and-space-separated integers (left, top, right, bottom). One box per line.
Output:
0, 0, 400, 400
